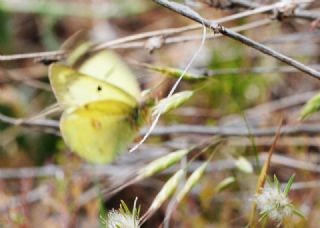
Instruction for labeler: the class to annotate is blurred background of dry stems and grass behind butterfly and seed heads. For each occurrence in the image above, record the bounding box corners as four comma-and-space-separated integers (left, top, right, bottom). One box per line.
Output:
0, 0, 320, 227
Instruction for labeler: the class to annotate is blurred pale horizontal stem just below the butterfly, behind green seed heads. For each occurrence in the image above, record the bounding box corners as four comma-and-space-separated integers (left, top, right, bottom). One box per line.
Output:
0, 150, 320, 179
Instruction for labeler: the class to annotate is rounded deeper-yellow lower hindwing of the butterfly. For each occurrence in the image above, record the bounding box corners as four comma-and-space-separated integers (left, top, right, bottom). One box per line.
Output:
60, 100, 140, 164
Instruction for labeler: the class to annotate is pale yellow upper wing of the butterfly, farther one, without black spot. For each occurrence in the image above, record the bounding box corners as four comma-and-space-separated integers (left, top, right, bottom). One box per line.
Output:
78, 50, 141, 101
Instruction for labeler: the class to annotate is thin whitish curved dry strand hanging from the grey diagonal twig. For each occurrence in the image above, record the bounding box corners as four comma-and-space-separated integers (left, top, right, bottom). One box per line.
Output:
129, 7, 207, 153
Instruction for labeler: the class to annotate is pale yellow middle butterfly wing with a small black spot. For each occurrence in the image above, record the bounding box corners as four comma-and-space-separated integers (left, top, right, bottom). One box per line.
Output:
49, 64, 137, 108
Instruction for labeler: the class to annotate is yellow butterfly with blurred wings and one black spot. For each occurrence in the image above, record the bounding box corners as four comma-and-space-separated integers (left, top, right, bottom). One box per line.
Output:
49, 50, 148, 164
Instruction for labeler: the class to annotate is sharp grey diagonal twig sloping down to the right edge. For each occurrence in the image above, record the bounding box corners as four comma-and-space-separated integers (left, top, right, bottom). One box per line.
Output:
153, 0, 320, 79
